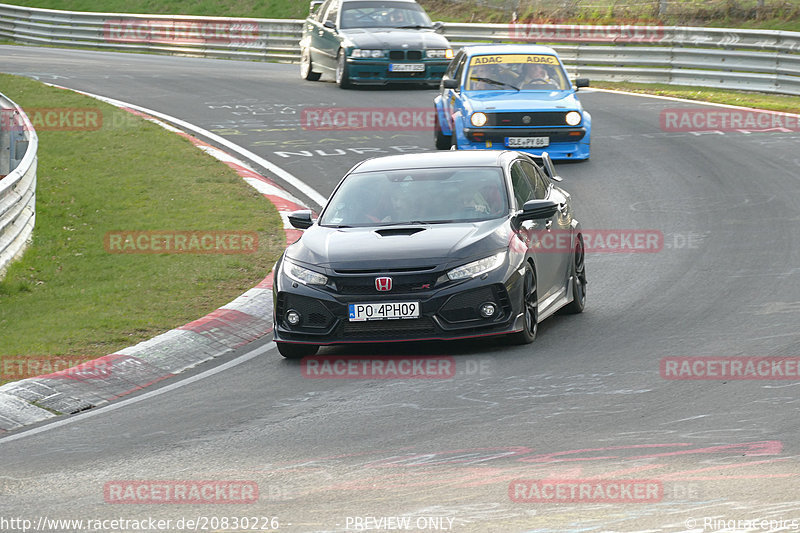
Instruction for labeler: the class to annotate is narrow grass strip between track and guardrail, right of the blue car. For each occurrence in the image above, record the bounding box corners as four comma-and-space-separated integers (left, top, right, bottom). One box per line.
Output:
591, 80, 800, 113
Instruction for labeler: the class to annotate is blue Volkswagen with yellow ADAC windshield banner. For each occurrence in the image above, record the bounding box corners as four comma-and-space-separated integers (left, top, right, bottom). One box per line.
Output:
434, 44, 592, 160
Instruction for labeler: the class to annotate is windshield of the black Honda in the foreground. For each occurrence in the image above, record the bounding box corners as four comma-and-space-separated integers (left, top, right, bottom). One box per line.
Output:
319, 167, 508, 227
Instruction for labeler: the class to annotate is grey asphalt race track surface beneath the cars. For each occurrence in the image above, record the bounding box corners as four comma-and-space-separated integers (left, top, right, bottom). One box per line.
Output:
0, 46, 800, 532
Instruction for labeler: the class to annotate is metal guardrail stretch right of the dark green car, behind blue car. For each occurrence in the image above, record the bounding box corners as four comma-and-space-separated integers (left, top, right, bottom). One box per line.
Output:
445, 24, 800, 95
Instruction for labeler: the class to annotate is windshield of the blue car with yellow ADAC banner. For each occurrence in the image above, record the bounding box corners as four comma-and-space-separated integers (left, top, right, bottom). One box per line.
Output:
466, 54, 571, 91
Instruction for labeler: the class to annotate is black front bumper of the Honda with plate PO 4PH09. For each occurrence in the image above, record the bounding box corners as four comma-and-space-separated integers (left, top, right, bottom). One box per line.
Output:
273, 269, 522, 345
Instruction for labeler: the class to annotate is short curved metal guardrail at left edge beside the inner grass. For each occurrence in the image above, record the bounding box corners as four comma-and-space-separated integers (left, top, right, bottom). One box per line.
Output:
0, 94, 39, 279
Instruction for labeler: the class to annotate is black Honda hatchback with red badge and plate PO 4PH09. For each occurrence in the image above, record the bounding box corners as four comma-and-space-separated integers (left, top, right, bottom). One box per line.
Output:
273, 150, 586, 357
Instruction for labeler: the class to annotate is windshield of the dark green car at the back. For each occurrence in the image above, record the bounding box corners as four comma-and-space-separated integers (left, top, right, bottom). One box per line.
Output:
341, 2, 433, 29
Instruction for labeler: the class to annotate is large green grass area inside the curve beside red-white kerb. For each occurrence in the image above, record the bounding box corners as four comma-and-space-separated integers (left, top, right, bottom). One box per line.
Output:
0, 74, 284, 376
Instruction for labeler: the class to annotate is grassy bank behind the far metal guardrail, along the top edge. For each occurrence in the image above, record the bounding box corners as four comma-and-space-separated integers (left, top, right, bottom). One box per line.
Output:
8, 0, 800, 31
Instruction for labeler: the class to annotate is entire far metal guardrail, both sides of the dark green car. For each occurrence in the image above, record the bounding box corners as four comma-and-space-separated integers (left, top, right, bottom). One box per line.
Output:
0, 4, 800, 95
